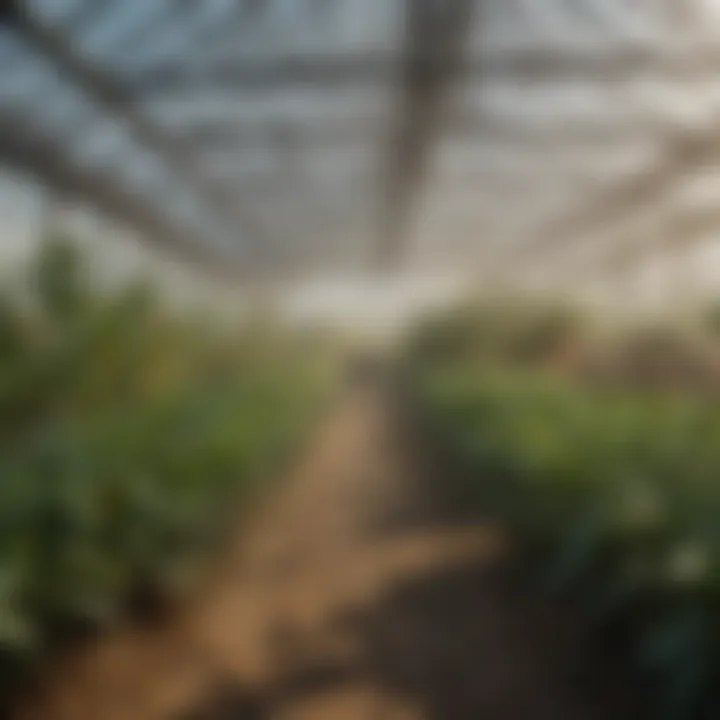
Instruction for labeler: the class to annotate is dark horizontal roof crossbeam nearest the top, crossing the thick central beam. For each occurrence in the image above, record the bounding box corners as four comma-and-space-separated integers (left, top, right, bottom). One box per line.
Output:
126, 46, 720, 97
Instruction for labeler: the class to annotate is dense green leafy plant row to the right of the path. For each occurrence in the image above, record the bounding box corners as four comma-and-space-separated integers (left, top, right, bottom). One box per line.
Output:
412, 300, 720, 719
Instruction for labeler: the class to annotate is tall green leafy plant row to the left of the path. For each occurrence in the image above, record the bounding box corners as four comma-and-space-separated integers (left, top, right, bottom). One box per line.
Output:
0, 241, 324, 677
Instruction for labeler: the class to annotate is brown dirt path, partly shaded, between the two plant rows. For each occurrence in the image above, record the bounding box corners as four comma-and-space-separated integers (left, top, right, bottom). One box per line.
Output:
19, 380, 635, 720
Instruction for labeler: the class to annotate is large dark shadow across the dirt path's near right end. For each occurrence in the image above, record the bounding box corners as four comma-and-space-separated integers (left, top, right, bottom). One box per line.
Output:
178, 548, 640, 720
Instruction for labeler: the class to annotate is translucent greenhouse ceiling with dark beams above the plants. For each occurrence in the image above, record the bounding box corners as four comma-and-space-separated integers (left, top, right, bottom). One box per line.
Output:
0, 0, 720, 277
